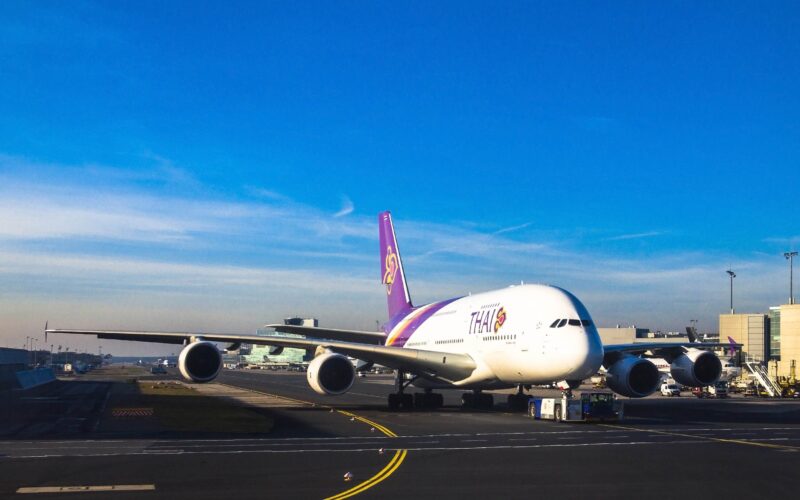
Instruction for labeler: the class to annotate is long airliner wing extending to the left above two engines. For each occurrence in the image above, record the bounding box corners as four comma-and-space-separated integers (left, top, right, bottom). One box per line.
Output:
46, 325, 477, 382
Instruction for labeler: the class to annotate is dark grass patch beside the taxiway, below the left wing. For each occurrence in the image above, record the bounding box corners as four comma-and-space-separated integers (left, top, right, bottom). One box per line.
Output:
139, 381, 273, 433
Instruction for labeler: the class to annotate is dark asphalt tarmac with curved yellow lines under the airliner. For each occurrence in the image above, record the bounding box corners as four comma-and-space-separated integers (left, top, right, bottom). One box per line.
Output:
0, 370, 800, 499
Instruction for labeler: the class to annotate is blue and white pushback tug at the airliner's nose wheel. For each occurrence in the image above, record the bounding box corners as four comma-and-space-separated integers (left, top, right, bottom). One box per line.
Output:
528, 391, 623, 422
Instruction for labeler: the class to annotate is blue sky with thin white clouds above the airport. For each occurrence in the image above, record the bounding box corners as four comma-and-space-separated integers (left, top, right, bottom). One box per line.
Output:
0, 1, 800, 354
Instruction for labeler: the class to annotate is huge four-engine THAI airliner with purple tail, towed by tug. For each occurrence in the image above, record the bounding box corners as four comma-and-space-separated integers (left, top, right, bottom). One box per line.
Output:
46, 212, 722, 409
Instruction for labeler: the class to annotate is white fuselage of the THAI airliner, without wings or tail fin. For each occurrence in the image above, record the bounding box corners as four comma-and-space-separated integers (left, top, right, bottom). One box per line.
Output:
387, 285, 603, 389
